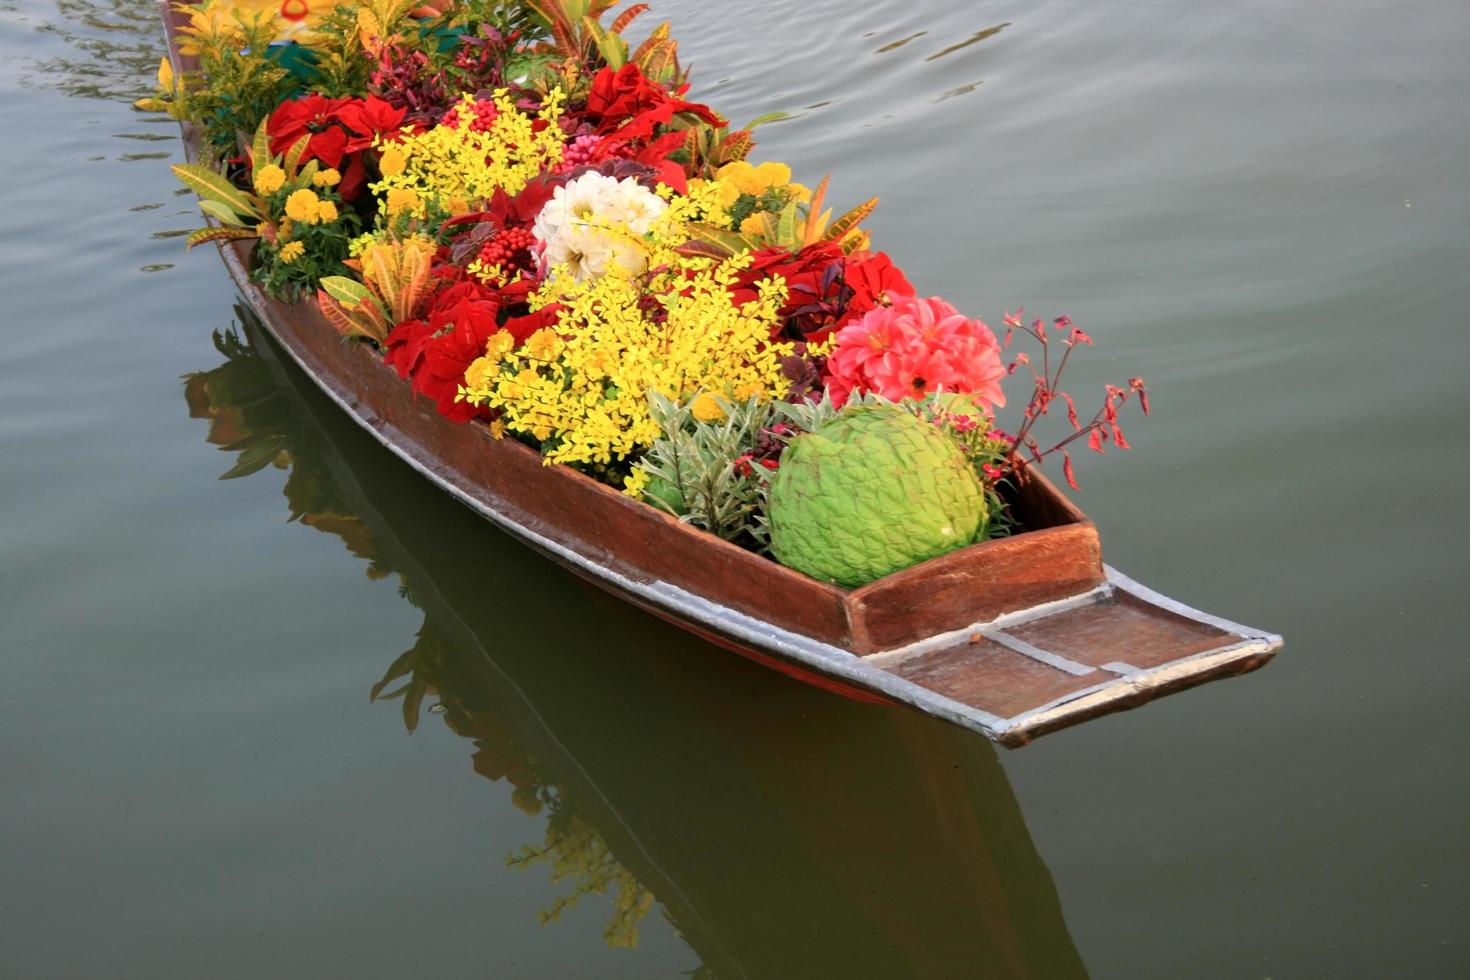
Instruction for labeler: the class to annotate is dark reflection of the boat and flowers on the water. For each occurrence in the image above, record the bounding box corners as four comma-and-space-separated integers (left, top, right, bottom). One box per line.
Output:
185, 309, 1085, 977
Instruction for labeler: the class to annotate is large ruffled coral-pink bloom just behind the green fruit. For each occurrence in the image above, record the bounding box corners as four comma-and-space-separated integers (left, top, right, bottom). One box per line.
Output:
826, 294, 1005, 410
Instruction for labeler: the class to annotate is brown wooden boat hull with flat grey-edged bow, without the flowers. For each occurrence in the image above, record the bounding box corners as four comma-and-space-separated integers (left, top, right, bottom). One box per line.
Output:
163, 4, 1282, 746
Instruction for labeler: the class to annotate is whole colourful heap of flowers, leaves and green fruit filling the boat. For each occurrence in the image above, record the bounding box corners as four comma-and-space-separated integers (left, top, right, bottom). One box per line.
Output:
155, 0, 1148, 586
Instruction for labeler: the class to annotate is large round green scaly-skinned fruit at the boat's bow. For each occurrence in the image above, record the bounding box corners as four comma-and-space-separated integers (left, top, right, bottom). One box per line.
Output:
766, 406, 986, 588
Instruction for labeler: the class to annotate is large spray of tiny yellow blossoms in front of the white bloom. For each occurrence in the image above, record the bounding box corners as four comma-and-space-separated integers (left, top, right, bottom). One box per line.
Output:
460, 191, 792, 466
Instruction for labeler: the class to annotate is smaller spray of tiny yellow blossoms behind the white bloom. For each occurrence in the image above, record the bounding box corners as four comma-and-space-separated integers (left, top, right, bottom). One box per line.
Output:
370, 88, 566, 219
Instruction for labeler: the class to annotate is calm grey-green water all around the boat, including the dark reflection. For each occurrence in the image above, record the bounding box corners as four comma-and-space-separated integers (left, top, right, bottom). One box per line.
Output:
0, 0, 1470, 979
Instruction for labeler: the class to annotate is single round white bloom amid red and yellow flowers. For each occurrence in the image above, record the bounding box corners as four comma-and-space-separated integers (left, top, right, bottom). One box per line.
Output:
531, 173, 669, 282
